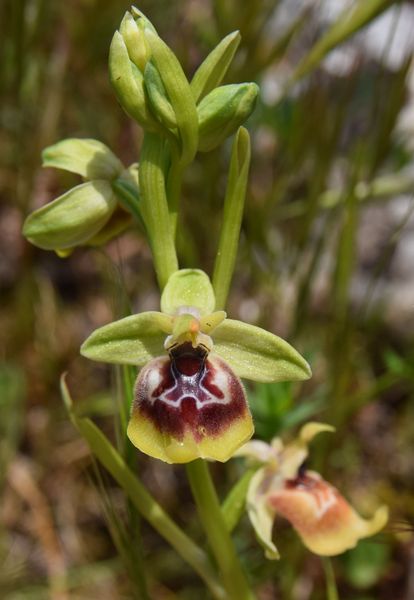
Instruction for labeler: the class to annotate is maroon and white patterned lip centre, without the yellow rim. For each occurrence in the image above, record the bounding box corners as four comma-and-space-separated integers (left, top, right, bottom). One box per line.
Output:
134, 343, 248, 443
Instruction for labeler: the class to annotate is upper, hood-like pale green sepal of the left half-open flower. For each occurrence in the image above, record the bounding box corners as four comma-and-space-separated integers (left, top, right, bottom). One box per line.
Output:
42, 138, 124, 180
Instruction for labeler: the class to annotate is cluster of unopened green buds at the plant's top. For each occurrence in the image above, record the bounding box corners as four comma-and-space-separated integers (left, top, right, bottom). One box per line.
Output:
109, 7, 258, 152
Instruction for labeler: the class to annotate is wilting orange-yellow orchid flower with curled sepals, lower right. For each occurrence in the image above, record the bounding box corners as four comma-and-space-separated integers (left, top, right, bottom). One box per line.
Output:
236, 423, 388, 559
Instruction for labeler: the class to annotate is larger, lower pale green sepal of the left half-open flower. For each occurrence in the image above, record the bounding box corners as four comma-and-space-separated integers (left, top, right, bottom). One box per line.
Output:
23, 180, 117, 250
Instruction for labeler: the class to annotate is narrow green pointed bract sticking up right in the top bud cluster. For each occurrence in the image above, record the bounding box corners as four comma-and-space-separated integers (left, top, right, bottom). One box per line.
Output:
190, 31, 241, 102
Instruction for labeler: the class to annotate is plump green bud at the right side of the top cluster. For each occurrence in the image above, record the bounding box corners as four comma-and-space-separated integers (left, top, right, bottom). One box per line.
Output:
197, 83, 259, 152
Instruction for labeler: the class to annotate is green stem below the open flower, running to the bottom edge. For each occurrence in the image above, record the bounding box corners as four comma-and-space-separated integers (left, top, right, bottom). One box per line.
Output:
187, 459, 254, 600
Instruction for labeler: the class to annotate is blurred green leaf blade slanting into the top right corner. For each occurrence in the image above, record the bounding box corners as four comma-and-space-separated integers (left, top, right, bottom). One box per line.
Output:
292, 0, 394, 81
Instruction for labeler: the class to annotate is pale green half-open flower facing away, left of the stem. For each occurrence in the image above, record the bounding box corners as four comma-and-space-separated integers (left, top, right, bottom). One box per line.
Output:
23, 138, 138, 257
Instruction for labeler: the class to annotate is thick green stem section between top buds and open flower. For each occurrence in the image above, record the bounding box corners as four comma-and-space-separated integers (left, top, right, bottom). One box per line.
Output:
139, 133, 178, 290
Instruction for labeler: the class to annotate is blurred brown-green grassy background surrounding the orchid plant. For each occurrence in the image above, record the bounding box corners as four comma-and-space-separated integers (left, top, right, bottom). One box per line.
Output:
0, 0, 414, 600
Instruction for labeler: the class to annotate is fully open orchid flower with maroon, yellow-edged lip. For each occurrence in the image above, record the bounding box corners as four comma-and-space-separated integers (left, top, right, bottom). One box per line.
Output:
81, 269, 310, 463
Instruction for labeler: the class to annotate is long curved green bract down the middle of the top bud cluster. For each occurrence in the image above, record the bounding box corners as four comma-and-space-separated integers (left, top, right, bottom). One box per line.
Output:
145, 29, 198, 165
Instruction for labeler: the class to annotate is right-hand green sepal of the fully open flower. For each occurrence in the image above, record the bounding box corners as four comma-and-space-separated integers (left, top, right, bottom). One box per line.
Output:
213, 319, 311, 382
